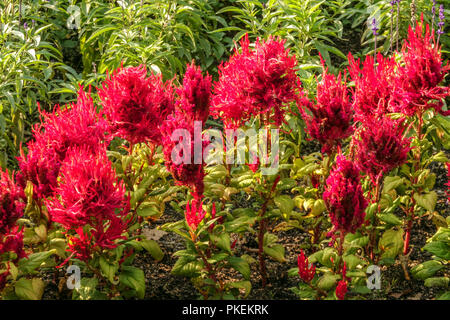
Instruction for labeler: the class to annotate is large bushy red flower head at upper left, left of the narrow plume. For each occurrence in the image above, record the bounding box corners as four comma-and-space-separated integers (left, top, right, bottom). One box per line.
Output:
98, 65, 174, 145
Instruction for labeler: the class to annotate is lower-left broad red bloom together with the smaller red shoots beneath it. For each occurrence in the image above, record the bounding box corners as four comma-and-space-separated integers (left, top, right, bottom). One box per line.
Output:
46, 148, 129, 261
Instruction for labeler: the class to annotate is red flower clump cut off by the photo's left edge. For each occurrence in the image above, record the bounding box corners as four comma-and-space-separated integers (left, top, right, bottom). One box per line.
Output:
0, 171, 26, 292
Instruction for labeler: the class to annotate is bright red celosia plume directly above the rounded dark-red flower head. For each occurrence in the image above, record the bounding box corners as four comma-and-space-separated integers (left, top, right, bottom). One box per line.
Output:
348, 53, 398, 122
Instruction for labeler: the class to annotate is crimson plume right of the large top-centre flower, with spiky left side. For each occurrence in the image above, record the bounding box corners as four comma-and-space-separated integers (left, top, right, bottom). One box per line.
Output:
300, 62, 353, 154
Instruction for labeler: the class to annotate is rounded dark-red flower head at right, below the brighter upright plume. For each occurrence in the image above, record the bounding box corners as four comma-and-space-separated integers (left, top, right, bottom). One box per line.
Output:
352, 116, 411, 183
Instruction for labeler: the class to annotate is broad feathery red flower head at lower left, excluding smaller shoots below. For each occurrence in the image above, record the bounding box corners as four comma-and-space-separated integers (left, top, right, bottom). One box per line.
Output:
47, 148, 126, 229
